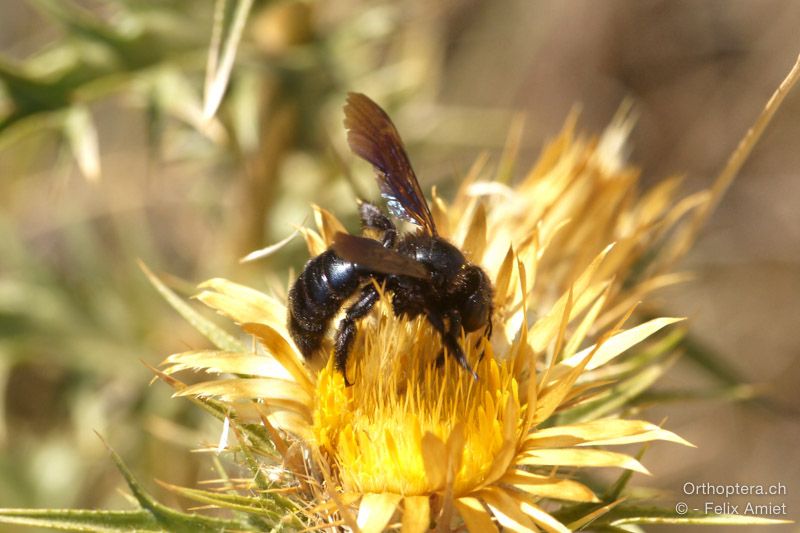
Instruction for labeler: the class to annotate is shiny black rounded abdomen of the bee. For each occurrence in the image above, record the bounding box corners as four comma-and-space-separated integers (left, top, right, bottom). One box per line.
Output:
289, 250, 360, 357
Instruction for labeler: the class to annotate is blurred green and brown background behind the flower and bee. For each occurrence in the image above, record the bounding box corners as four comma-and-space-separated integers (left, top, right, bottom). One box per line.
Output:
0, 0, 800, 531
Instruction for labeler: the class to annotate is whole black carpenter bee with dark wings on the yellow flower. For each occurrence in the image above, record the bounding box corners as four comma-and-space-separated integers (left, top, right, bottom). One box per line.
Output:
289, 93, 492, 384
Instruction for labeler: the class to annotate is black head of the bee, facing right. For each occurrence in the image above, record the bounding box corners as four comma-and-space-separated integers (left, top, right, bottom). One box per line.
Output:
450, 264, 492, 331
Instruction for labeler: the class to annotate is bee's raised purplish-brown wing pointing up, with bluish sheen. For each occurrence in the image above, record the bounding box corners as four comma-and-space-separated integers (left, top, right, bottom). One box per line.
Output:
344, 93, 436, 235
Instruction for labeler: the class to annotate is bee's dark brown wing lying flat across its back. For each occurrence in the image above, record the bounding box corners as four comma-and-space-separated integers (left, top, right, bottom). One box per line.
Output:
331, 232, 430, 279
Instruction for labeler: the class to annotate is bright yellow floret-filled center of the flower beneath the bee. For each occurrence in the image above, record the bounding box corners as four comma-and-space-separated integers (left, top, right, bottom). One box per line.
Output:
313, 302, 520, 495
